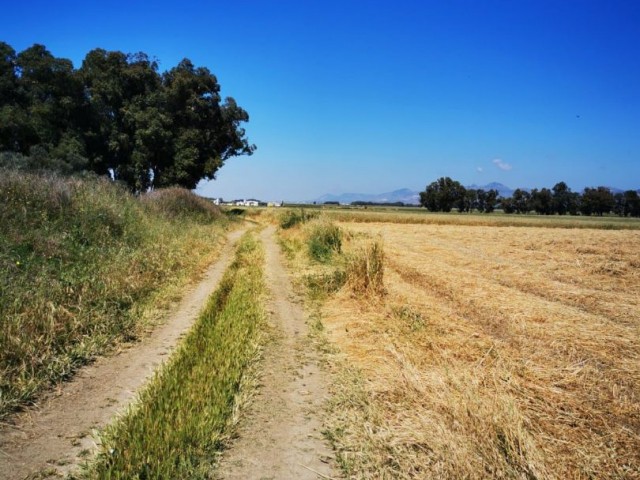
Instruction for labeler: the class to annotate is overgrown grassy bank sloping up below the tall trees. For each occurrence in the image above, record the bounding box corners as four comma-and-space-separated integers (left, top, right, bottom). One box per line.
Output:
0, 170, 227, 418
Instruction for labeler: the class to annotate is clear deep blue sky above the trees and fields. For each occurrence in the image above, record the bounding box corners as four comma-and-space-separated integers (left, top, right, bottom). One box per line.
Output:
0, 0, 640, 200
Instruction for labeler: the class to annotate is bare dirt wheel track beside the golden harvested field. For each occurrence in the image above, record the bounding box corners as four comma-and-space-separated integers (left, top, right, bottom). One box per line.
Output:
218, 227, 337, 480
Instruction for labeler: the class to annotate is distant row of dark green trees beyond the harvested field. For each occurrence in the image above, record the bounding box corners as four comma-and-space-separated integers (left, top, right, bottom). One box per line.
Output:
420, 177, 640, 217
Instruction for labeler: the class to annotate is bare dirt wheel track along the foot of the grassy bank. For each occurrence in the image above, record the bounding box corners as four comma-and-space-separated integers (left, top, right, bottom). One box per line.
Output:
0, 230, 244, 480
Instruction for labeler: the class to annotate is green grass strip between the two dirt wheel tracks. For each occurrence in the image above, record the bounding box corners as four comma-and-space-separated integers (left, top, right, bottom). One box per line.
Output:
86, 234, 266, 479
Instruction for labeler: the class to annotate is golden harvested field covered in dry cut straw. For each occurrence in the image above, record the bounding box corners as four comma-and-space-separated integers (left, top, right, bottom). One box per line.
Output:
322, 223, 640, 479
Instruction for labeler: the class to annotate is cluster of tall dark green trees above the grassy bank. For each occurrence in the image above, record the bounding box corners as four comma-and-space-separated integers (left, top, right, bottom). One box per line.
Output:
0, 42, 256, 191
